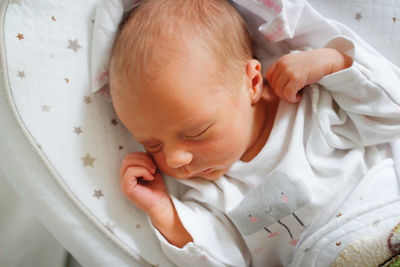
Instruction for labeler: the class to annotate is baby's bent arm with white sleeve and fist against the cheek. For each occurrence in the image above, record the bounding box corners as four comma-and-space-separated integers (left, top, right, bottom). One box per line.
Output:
120, 153, 250, 267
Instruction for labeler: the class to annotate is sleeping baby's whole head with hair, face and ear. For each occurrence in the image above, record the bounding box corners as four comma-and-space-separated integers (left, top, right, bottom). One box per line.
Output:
110, 0, 263, 180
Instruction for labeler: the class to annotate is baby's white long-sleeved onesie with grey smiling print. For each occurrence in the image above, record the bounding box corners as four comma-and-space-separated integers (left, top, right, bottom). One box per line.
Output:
148, 34, 400, 267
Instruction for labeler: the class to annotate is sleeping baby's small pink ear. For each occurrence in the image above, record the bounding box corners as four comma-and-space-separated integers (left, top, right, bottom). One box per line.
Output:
246, 59, 264, 105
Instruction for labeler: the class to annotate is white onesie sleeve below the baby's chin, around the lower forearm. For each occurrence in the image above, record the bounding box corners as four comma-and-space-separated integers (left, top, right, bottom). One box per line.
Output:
149, 196, 250, 267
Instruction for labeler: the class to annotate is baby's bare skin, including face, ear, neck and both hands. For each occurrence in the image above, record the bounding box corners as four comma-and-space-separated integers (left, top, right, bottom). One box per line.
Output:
113, 48, 352, 248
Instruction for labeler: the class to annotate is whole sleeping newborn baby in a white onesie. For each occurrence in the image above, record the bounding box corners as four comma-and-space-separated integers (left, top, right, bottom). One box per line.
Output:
110, 0, 400, 266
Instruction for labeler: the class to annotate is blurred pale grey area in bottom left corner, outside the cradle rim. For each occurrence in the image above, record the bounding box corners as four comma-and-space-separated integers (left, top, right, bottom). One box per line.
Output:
0, 170, 67, 267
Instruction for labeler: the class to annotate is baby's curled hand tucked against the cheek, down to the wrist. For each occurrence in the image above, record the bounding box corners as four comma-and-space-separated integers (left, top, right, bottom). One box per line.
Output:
120, 152, 170, 215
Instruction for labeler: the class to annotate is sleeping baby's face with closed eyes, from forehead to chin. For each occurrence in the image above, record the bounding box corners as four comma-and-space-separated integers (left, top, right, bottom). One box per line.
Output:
113, 46, 260, 180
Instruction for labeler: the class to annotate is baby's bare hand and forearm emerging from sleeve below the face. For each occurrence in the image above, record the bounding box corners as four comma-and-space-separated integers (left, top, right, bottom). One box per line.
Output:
120, 152, 193, 248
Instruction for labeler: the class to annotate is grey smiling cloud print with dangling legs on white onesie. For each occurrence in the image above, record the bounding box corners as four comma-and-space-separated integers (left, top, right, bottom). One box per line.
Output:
228, 171, 311, 246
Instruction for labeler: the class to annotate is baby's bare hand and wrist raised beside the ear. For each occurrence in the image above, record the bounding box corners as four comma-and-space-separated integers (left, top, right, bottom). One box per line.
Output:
266, 48, 352, 103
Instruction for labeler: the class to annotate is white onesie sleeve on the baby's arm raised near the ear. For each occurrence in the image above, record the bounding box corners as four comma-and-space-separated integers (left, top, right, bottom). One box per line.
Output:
311, 36, 400, 149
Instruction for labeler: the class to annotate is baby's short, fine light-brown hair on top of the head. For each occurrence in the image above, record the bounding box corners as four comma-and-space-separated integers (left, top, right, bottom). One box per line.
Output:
110, 0, 253, 89
